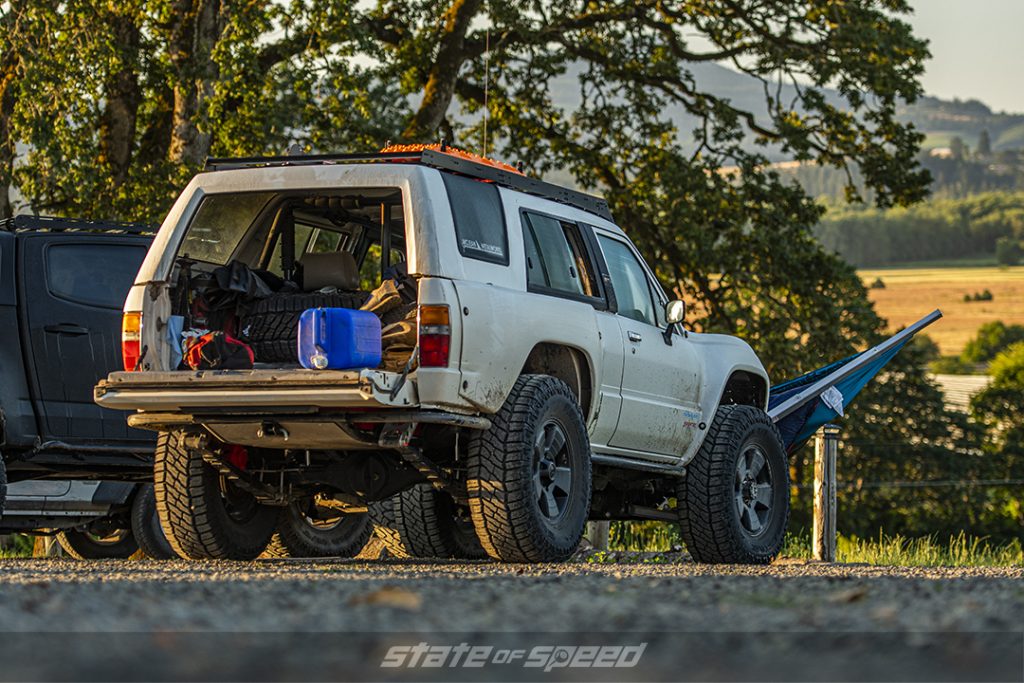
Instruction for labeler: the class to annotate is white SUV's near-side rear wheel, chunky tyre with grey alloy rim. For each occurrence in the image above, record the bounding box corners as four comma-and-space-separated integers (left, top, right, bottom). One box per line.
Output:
467, 375, 591, 562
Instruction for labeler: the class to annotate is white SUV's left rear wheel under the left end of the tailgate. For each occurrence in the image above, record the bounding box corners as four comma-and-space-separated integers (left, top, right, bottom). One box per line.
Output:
154, 432, 280, 560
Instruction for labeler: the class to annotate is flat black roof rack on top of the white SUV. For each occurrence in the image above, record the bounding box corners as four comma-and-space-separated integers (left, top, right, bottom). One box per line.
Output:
203, 150, 613, 220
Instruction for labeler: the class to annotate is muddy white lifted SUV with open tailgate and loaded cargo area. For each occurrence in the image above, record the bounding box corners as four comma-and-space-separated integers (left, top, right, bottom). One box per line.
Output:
95, 146, 788, 563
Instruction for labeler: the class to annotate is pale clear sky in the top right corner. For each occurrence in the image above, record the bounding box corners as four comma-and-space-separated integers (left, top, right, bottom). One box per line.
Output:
909, 0, 1024, 113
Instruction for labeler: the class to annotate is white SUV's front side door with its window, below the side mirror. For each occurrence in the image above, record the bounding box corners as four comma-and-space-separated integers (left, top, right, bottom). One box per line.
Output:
596, 232, 701, 456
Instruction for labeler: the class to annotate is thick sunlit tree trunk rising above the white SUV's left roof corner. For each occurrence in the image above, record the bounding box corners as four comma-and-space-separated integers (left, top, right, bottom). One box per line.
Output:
168, 0, 222, 166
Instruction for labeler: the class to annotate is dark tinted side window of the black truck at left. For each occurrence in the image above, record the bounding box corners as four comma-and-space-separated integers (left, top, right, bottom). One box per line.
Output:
46, 244, 145, 310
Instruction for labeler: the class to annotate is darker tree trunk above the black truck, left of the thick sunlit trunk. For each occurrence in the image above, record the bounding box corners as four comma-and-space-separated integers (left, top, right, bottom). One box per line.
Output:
99, 14, 142, 187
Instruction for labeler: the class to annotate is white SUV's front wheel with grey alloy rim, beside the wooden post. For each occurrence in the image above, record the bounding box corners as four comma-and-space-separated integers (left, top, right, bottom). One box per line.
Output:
677, 405, 790, 564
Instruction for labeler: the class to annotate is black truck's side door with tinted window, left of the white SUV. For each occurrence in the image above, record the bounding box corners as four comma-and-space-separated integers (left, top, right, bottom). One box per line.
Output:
19, 232, 152, 442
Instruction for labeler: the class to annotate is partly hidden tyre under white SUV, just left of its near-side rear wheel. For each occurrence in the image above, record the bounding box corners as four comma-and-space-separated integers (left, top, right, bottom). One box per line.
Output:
370, 483, 486, 559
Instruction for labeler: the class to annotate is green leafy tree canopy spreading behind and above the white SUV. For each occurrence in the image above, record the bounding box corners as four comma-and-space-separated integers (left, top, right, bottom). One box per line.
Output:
4, 0, 928, 374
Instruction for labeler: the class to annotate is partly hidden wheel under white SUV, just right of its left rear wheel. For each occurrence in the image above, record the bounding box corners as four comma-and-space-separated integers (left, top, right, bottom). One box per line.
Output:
265, 503, 373, 557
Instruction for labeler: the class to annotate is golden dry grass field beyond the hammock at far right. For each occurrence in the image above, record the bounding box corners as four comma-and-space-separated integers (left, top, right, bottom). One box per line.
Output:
859, 266, 1024, 355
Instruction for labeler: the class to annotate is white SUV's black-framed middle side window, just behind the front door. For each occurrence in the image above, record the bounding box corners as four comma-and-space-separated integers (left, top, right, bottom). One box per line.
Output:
522, 213, 599, 297
